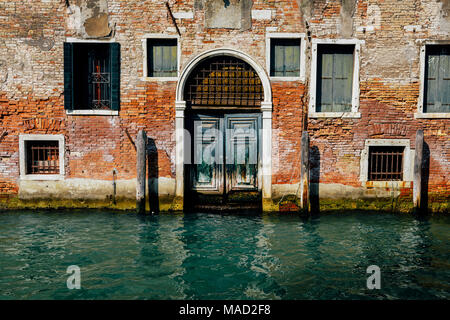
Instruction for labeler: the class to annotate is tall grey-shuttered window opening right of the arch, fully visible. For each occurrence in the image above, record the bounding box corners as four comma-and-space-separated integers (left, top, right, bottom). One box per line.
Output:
316, 45, 354, 112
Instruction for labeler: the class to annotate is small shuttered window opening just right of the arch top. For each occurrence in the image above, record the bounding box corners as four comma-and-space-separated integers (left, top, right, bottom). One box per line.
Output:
270, 38, 301, 77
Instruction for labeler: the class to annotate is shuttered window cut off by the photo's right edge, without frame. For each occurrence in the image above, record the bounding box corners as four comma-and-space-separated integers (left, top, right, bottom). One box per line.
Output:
424, 45, 450, 113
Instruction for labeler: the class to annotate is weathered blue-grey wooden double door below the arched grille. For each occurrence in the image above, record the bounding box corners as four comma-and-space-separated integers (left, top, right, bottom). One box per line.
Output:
189, 113, 261, 210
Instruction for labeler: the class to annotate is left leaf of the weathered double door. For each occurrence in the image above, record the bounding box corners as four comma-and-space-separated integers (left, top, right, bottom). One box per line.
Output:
191, 115, 223, 194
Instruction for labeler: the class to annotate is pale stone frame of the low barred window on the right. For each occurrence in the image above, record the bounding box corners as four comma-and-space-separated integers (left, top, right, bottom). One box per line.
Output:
359, 139, 414, 187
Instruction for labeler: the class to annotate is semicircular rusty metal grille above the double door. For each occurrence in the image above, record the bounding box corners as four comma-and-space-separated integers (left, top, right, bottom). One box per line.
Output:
185, 56, 264, 107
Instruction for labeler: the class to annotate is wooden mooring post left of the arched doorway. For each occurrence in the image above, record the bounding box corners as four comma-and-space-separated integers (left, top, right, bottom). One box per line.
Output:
136, 130, 147, 214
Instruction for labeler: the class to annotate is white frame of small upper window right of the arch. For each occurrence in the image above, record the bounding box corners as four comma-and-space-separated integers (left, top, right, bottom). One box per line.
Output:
266, 32, 306, 81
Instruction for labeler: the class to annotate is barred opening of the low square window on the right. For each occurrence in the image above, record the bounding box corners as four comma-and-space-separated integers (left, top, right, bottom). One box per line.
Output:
368, 146, 404, 181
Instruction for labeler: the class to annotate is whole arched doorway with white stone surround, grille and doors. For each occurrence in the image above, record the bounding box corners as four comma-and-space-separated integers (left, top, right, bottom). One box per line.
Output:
176, 49, 272, 210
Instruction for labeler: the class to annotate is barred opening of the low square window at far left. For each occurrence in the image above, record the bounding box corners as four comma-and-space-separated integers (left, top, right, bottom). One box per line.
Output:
27, 141, 59, 174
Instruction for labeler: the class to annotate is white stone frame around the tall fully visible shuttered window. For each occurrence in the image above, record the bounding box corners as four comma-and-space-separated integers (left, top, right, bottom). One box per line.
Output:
308, 39, 364, 118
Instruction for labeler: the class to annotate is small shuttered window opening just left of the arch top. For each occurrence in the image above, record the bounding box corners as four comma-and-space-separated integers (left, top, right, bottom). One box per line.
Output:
147, 38, 178, 77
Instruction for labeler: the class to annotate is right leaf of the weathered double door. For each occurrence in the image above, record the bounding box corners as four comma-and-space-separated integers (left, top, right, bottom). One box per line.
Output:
225, 114, 261, 192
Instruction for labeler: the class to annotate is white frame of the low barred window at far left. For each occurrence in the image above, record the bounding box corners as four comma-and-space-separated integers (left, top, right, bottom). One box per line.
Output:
19, 134, 65, 180
